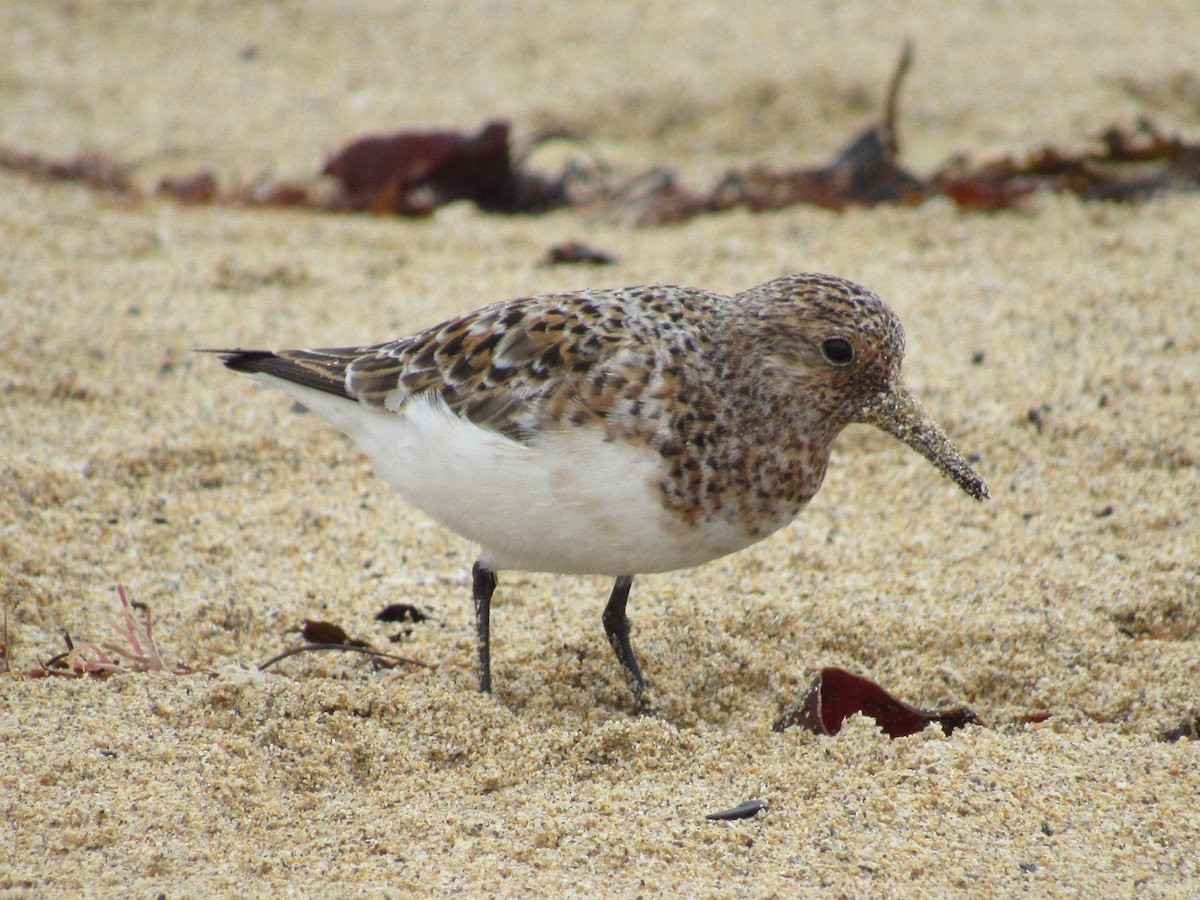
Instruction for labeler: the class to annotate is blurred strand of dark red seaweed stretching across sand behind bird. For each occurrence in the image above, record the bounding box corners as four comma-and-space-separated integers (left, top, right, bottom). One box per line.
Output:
0, 41, 1200, 224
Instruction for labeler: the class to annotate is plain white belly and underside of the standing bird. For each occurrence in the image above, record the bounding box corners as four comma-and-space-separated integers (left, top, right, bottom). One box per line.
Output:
259, 376, 761, 576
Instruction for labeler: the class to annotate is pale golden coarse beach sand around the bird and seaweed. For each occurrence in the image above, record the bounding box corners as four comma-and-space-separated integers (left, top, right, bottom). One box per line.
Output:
0, 0, 1200, 896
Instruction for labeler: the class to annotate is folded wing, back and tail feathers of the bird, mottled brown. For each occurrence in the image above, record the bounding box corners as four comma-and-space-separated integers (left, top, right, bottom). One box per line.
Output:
206, 286, 721, 440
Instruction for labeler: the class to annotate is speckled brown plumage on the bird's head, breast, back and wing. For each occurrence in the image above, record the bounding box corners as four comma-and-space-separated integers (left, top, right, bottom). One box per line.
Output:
246, 275, 904, 536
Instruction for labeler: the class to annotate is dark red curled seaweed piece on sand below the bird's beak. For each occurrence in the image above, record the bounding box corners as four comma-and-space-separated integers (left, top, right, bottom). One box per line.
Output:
772, 667, 983, 739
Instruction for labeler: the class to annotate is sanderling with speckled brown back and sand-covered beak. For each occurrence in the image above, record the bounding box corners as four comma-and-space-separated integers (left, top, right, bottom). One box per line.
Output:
217, 274, 988, 710
